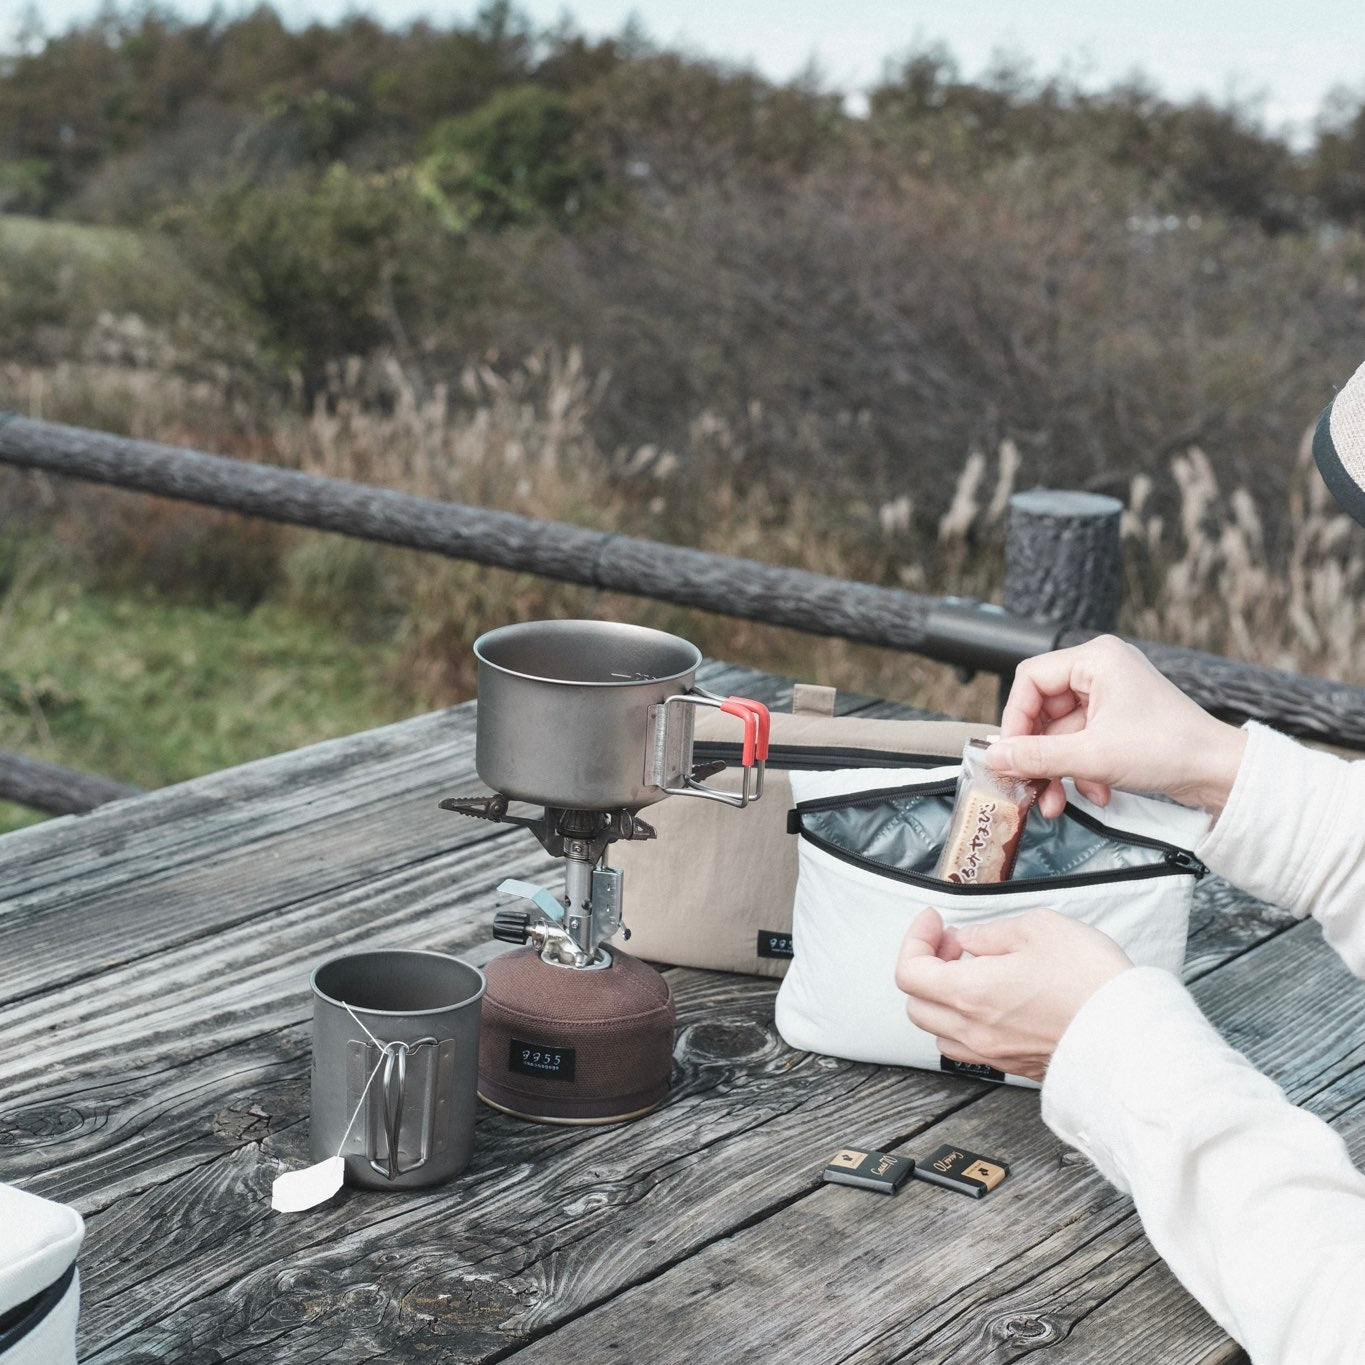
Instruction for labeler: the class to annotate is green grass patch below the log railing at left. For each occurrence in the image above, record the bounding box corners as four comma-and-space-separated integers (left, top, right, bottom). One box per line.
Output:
0, 551, 428, 829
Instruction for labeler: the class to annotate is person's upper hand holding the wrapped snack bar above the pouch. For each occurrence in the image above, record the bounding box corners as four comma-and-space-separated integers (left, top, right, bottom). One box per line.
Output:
986, 635, 1246, 818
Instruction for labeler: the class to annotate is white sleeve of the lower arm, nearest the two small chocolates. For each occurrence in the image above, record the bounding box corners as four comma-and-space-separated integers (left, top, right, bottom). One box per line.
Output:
1043, 968, 1365, 1365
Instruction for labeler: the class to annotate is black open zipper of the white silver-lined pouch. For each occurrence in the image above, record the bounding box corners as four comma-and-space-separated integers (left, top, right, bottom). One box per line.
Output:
788, 779, 1208, 895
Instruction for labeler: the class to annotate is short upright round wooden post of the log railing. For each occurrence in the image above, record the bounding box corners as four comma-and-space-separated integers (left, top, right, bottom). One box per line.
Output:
1001, 489, 1123, 710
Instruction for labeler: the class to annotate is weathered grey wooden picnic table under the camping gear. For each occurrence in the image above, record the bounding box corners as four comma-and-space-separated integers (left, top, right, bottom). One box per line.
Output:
0, 663, 1365, 1365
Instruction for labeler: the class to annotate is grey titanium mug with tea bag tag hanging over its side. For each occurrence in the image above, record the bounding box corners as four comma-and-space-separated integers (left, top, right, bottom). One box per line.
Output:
310, 949, 487, 1189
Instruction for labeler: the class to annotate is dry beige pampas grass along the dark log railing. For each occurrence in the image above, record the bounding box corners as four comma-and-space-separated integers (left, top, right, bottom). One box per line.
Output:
0, 343, 1365, 715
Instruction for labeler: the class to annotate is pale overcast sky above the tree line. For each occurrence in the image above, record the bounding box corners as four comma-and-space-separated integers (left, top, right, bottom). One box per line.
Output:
10, 0, 1365, 135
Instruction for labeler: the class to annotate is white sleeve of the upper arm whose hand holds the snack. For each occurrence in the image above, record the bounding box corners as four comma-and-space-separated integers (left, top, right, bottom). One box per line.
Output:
1196, 725, 1365, 976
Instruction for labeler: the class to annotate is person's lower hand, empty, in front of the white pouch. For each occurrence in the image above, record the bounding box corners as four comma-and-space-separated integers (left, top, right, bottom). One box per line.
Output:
895, 909, 1133, 1081
